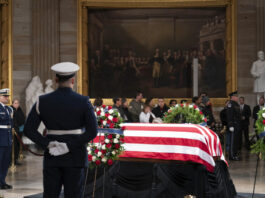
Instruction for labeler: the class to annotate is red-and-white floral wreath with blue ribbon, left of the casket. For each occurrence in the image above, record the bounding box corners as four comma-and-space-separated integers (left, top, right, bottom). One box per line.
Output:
87, 105, 124, 168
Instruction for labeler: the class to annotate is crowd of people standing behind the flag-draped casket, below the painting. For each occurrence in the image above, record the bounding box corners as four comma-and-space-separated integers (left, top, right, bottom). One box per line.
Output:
94, 92, 264, 160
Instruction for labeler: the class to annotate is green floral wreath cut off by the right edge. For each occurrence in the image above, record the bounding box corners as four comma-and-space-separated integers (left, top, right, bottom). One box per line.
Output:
251, 107, 265, 160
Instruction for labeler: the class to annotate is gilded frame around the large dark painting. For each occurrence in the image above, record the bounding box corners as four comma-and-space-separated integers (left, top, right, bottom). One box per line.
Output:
77, 0, 237, 106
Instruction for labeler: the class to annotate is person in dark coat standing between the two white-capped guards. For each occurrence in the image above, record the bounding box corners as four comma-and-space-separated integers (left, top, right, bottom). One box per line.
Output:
11, 99, 25, 165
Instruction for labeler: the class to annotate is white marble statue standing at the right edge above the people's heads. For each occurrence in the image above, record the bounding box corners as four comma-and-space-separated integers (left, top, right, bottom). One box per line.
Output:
251, 51, 265, 103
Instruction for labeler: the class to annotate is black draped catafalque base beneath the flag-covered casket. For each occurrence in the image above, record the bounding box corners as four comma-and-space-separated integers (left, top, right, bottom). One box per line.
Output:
27, 161, 254, 198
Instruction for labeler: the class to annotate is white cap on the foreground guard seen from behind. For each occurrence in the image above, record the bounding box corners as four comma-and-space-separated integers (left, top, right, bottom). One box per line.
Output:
51, 62, 79, 77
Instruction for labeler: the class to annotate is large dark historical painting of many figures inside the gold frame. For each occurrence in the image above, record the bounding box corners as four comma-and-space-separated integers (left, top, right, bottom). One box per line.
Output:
88, 7, 226, 98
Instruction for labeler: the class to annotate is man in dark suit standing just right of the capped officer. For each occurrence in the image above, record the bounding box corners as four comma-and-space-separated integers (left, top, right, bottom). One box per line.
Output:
239, 96, 251, 150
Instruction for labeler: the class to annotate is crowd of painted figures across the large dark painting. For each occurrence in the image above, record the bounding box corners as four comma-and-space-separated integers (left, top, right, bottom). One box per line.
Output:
89, 45, 226, 97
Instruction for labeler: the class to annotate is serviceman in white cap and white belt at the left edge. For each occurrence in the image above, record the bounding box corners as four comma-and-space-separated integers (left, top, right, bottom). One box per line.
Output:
0, 89, 13, 189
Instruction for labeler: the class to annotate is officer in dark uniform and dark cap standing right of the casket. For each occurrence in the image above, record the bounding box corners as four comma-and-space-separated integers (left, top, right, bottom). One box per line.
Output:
226, 91, 241, 161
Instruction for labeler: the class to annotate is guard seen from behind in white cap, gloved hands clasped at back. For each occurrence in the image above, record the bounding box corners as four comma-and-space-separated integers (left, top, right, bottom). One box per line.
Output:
24, 62, 97, 198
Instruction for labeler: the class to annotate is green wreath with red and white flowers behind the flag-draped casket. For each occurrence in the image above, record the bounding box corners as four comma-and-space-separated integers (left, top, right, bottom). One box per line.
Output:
163, 103, 207, 125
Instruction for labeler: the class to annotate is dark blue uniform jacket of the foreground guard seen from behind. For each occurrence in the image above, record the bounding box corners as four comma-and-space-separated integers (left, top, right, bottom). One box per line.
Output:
24, 87, 97, 167
